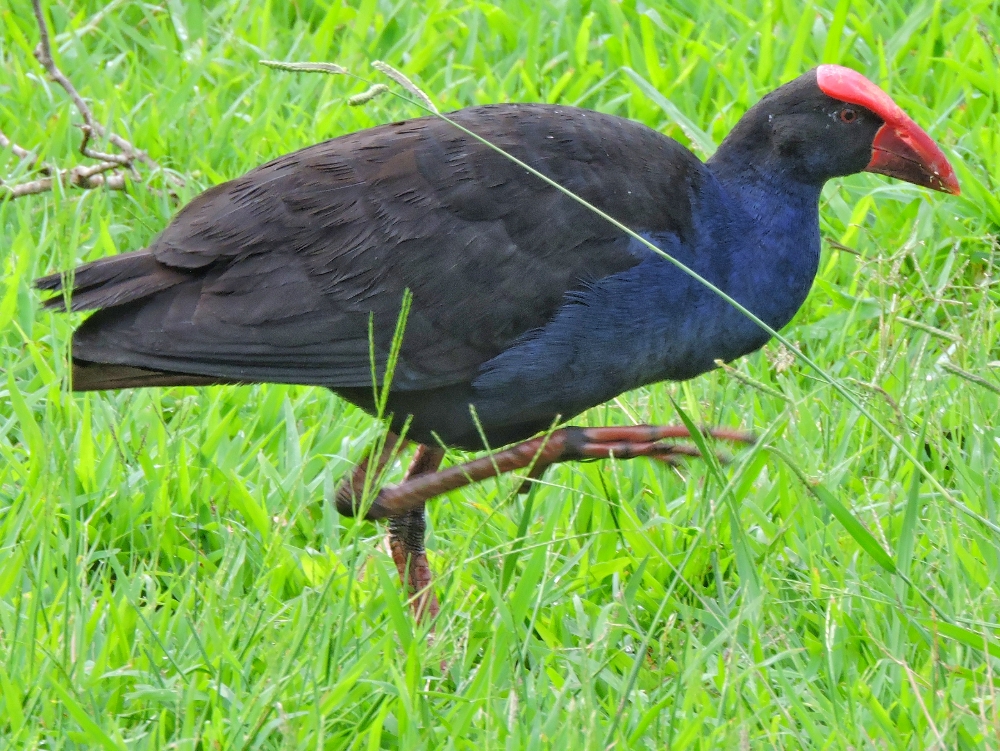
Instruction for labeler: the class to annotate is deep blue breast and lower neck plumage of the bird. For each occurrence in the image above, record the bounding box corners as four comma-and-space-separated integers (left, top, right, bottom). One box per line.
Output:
473, 170, 820, 423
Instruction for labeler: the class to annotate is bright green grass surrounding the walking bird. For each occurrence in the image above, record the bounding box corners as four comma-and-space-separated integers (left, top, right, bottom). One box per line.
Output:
0, 0, 1000, 749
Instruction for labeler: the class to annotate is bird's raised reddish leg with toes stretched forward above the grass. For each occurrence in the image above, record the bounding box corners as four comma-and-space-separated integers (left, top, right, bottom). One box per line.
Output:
337, 425, 754, 519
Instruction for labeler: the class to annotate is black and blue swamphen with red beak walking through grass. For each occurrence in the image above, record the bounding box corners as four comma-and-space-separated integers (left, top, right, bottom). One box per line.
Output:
36, 65, 960, 618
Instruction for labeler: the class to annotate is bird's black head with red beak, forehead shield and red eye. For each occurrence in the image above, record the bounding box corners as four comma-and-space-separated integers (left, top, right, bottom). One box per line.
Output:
718, 65, 960, 195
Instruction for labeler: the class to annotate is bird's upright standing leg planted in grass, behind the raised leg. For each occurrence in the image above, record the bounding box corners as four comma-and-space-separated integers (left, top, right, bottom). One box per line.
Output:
388, 444, 444, 621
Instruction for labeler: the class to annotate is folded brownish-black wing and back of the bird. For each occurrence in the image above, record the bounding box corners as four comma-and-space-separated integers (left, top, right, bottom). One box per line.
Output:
39, 104, 705, 390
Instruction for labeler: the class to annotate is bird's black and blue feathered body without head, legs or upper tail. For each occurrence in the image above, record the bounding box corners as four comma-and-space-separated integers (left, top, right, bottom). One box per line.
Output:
41, 91, 836, 448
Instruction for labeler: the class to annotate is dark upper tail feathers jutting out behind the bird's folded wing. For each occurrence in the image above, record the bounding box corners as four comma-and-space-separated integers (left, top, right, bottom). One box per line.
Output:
35, 250, 189, 311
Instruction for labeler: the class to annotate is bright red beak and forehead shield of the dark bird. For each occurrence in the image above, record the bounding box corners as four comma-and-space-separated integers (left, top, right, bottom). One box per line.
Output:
816, 65, 962, 195
